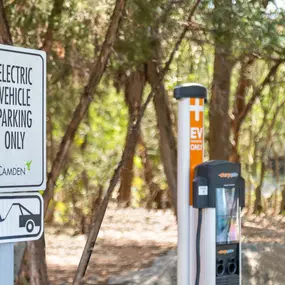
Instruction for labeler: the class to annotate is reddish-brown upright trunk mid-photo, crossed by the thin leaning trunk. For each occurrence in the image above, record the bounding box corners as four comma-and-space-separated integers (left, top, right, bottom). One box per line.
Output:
118, 70, 145, 206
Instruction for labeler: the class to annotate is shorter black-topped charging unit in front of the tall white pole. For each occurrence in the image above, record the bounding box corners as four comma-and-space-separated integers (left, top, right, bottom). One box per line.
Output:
193, 160, 244, 285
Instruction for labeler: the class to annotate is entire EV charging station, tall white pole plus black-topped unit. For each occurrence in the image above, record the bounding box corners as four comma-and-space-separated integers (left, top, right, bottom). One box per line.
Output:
174, 84, 244, 285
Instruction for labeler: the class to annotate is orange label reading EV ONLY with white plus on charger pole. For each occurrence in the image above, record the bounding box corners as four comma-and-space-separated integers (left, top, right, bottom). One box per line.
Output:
190, 98, 204, 205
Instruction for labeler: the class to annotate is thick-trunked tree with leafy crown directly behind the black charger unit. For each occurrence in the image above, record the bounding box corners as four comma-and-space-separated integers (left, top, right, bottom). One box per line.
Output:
203, 0, 283, 161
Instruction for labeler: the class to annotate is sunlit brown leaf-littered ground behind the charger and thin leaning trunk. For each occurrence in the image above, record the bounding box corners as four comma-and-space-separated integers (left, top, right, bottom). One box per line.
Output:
46, 206, 285, 285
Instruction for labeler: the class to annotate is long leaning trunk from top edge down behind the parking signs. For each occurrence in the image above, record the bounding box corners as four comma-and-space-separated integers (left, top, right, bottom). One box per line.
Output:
29, 0, 125, 285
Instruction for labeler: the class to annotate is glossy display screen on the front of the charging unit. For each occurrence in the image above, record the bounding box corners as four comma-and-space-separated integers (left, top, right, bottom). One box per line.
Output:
216, 187, 240, 244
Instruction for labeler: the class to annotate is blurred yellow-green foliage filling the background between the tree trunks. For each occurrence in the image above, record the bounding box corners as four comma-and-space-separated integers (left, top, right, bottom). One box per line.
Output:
5, 0, 285, 224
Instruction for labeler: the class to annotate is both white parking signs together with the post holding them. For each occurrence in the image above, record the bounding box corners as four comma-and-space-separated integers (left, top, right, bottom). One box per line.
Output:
0, 45, 46, 285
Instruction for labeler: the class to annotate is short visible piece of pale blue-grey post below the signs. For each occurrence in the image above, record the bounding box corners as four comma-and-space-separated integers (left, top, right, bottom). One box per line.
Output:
0, 243, 14, 285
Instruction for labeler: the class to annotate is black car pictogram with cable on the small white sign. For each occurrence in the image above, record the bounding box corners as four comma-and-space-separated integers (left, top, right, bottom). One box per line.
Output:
0, 203, 41, 233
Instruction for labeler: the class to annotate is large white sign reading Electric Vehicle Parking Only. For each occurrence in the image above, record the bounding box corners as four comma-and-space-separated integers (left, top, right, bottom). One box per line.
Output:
0, 45, 46, 191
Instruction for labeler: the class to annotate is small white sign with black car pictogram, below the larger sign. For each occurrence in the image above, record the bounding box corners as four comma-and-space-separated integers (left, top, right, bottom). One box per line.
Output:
0, 193, 44, 243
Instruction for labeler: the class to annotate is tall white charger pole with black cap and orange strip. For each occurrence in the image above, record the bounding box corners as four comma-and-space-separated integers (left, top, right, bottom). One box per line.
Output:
174, 83, 207, 285
